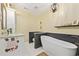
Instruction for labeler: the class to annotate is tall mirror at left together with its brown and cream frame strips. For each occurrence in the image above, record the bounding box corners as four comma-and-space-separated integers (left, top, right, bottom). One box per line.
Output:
1, 3, 15, 33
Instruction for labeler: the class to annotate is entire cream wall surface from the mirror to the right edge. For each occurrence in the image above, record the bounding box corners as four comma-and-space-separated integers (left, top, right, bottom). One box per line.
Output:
16, 4, 79, 41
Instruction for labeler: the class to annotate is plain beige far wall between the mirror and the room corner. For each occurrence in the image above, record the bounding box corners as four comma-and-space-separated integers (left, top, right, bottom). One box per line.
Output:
16, 9, 39, 41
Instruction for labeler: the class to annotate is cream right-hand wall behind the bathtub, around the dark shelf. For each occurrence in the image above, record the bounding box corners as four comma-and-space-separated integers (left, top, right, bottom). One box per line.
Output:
39, 4, 79, 35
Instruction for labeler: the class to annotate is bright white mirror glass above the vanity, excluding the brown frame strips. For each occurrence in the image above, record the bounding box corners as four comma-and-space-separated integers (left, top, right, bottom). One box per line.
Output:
6, 8, 15, 33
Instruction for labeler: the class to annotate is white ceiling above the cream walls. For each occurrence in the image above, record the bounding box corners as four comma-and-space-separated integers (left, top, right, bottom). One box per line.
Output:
15, 3, 52, 14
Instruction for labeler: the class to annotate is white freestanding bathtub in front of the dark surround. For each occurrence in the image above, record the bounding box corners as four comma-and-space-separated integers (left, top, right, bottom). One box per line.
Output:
41, 35, 77, 56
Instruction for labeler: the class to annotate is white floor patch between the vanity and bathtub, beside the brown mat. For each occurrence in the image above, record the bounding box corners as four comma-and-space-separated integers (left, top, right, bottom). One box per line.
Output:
27, 43, 45, 56
